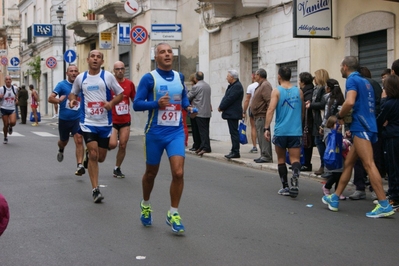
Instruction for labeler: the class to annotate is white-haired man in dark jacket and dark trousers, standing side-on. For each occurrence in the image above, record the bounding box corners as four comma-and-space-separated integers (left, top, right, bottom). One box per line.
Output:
218, 70, 244, 159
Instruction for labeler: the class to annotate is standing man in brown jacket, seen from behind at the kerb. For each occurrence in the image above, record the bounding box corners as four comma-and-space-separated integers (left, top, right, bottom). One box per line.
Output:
251, 68, 273, 163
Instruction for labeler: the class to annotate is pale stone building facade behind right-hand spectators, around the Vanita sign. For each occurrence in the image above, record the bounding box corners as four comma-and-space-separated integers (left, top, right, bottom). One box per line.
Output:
199, 0, 399, 140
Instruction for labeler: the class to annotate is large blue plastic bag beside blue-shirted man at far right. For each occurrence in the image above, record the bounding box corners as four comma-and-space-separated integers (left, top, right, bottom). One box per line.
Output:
323, 124, 343, 170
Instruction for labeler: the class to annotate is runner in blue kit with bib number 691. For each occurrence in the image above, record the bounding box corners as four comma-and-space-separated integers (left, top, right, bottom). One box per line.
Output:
133, 43, 193, 234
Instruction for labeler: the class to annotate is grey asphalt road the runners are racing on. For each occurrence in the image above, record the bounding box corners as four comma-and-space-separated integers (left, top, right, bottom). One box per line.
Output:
0, 120, 399, 266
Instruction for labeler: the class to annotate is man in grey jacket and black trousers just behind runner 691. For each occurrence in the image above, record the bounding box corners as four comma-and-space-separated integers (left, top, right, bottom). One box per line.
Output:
187, 71, 212, 156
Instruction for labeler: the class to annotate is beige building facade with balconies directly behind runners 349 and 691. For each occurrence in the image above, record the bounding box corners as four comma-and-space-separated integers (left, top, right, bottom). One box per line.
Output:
67, 0, 199, 130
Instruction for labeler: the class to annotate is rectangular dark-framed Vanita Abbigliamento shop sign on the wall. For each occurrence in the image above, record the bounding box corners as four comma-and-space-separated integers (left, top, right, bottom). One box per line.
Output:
293, 0, 332, 38
